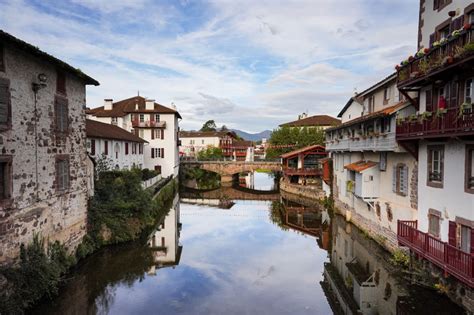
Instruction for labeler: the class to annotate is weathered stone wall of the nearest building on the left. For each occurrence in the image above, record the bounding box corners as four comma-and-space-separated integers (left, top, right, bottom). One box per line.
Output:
0, 42, 88, 263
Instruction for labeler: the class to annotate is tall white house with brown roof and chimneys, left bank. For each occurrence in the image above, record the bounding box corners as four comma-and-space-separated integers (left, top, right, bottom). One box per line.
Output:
87, 96, 181, 177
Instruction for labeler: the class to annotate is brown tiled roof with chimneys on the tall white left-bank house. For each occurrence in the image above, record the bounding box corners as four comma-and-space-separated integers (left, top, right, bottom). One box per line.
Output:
86, 96, 181, 118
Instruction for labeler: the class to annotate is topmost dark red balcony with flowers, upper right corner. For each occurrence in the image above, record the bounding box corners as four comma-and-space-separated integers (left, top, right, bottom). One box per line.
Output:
397, 27, 474, 87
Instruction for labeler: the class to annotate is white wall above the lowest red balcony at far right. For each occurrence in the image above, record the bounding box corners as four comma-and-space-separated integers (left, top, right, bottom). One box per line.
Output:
418, 140, 474, 242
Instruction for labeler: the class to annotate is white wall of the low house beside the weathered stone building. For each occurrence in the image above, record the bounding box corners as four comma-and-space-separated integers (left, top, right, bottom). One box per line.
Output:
87, 138, 144, 169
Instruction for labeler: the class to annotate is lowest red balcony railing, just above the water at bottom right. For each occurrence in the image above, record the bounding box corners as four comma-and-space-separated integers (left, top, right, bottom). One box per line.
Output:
397, 220, 474, 287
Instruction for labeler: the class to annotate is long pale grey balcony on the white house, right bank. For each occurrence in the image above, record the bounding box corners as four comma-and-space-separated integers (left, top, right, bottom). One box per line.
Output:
326, 132, 398, 151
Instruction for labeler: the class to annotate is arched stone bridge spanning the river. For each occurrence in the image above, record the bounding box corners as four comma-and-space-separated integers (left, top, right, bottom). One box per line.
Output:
180, 161, 282, 186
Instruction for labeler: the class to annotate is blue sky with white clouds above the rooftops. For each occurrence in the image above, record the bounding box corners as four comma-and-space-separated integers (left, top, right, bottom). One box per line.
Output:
0, 0, 419, 132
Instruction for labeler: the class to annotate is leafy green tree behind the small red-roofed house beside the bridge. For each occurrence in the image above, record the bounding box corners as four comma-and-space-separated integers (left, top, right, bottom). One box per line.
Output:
267, 126, 324, 158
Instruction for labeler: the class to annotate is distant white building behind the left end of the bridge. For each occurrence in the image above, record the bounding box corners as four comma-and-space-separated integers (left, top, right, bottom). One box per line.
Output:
179, 131, 236, 158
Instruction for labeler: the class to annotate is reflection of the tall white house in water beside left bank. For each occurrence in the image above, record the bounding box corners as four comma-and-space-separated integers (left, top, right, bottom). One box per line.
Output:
148, 195, 182, 274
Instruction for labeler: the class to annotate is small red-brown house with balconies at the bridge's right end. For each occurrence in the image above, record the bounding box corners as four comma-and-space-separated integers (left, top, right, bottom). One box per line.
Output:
281, 145, 327, 184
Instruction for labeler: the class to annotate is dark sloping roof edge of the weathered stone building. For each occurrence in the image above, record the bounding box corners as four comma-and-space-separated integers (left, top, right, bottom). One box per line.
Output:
0, 30, 99, 85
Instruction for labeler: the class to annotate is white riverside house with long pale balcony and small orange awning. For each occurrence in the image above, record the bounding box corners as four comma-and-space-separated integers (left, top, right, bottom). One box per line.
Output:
326, 74, 417, 252
